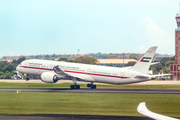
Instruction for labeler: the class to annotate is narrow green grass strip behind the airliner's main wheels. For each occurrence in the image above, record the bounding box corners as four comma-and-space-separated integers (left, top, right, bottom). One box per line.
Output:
0, 82, 180, 89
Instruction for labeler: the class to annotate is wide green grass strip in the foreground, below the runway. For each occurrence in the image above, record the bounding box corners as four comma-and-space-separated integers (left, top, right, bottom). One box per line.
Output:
0, 92, 180, 117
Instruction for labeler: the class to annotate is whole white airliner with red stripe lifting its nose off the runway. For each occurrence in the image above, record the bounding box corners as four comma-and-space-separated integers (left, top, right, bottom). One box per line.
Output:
16, 46, 157, 89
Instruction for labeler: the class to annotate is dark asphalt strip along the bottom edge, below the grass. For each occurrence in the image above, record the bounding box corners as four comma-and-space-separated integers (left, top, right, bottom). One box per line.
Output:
0, 114, 153, 120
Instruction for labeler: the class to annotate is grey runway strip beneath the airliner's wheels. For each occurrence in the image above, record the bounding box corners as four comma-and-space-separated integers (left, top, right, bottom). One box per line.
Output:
0, 87, 180, 94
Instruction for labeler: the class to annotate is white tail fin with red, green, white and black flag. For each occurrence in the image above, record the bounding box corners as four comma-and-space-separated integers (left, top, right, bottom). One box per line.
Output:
131, 46, 157, 74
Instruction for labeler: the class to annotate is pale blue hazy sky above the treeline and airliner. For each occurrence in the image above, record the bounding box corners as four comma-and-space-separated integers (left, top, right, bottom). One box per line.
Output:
0, 0, 180, 57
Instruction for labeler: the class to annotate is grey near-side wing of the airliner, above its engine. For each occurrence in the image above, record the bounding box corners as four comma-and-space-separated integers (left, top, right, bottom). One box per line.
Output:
53, 65, 84, 80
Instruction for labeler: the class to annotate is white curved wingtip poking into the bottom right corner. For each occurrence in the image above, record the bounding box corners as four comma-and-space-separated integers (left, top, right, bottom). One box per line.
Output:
137, 102, 179, 120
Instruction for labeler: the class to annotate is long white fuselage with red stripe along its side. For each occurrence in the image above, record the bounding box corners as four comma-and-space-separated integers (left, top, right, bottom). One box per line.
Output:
17, 59, 151, 84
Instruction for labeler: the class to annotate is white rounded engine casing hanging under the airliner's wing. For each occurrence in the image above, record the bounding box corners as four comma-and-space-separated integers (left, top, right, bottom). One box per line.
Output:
41, 72, 59, 83
